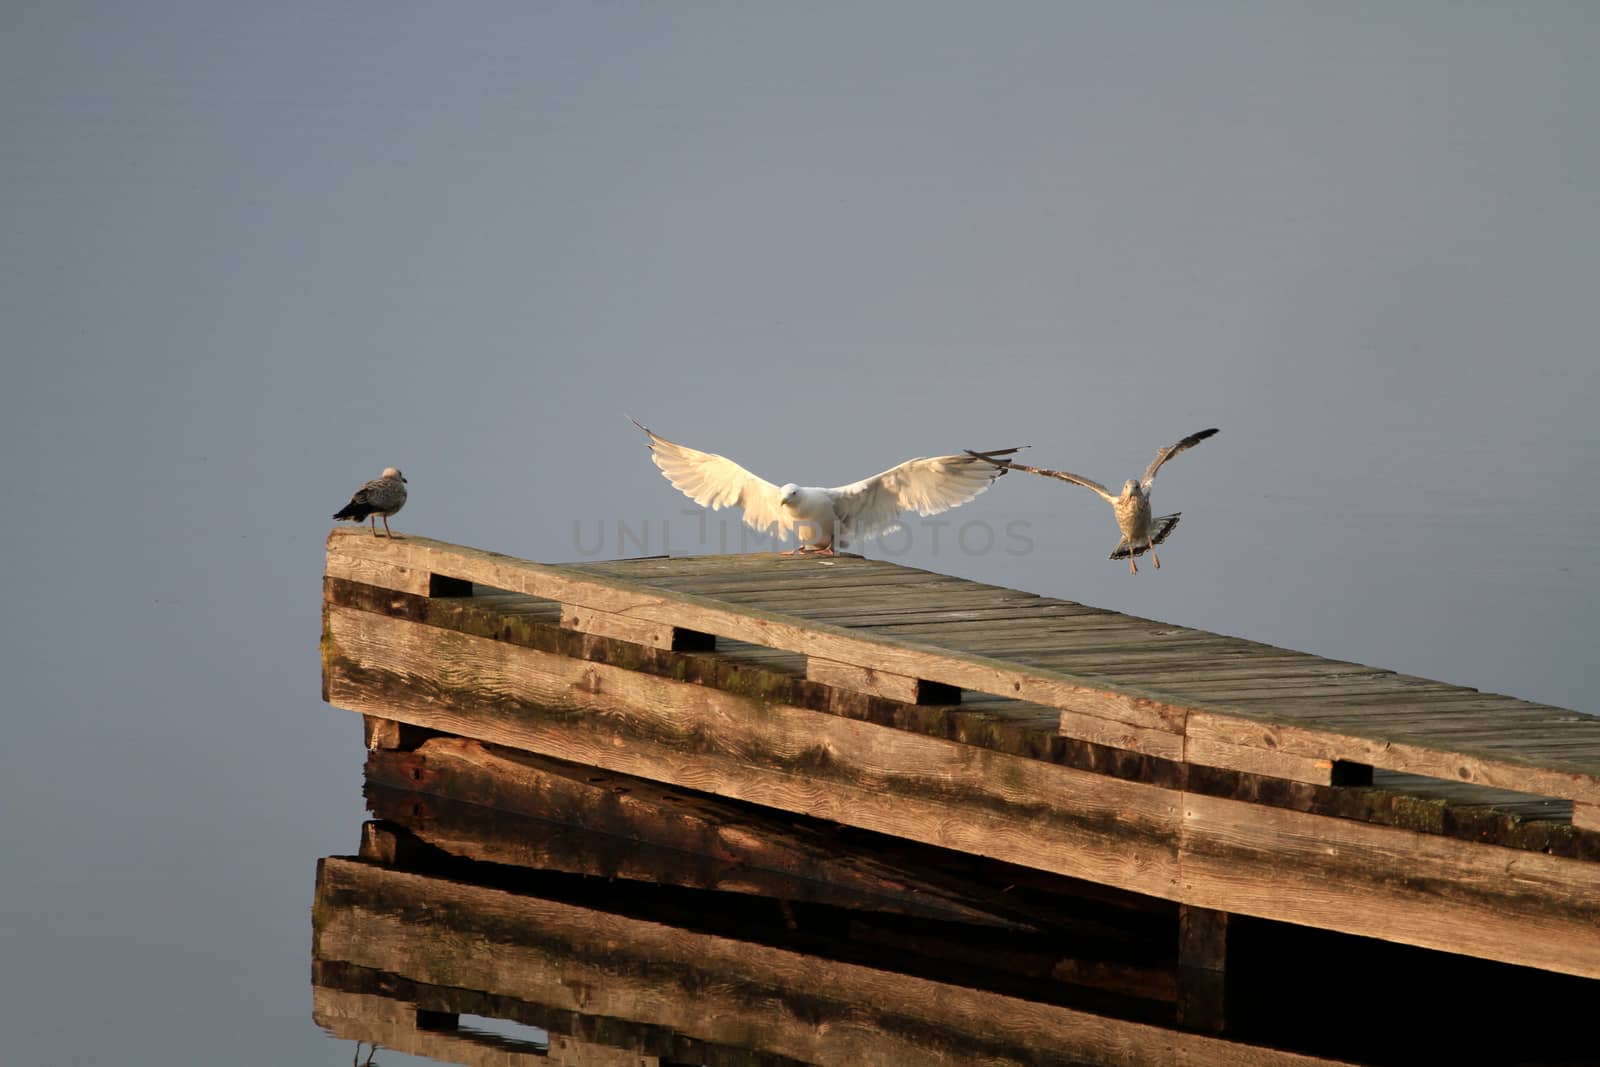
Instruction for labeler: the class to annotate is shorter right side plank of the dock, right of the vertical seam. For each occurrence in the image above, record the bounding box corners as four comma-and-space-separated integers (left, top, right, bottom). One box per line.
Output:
1179, 793, 1600, 977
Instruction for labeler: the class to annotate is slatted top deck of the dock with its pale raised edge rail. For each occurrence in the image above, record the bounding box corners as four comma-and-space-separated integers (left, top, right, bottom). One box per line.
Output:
328, 530, 1600, 805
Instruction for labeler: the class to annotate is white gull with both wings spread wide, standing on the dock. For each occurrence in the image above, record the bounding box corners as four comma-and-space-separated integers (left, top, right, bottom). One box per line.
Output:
632, 419, 1018, 555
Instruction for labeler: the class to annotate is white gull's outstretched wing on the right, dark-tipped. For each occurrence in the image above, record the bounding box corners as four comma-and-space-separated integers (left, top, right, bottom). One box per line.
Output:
827, 448, 1018, 537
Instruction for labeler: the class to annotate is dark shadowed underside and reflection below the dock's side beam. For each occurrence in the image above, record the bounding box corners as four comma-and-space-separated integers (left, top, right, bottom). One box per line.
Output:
312, 737, 1590, 1065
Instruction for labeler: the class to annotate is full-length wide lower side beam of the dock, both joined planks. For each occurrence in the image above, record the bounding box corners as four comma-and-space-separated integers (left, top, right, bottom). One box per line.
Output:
326, 606, 1600, 977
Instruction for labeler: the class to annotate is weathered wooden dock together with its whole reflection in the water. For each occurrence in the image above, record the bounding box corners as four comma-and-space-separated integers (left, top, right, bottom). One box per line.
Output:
314, 533, 1600, 1064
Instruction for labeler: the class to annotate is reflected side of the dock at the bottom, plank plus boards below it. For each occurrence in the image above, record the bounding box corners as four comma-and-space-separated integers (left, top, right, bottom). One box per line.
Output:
314, 856, 1341, 1067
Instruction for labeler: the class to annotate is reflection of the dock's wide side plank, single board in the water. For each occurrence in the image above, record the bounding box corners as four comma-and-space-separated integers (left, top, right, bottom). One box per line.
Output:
315, 857, 1350, 1067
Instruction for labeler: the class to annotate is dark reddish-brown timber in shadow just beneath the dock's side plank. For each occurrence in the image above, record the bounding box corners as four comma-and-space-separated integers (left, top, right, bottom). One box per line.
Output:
363, 737, 1026, 925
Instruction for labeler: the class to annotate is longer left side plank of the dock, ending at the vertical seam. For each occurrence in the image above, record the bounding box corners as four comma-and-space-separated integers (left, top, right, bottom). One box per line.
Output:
325, 606, 1178, 896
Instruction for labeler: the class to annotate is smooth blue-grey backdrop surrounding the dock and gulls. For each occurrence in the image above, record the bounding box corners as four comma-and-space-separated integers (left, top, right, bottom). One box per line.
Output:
0, 0, 1600, 1064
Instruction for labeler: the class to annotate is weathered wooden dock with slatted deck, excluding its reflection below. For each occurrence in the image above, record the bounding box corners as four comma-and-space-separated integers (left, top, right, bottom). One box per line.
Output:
323, 530, 1600, 1062
